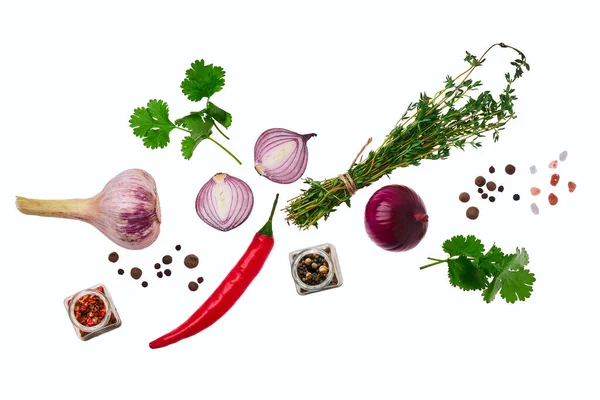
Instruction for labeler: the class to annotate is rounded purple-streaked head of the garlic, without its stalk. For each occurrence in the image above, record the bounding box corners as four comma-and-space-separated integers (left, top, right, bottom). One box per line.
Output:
86, 169, 161, 250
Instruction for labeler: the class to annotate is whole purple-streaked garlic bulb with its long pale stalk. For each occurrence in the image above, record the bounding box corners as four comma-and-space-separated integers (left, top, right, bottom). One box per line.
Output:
16, 169, 160, 250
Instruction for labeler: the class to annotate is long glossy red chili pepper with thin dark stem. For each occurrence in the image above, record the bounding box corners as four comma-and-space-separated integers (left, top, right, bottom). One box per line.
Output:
150, 194, 279, 349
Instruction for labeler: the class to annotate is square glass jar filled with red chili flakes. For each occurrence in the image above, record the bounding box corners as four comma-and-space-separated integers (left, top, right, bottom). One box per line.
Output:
64, 284, 121, 340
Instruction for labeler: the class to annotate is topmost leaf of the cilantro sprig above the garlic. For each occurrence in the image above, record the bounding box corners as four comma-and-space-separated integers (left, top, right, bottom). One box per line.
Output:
181, 60, 225, 101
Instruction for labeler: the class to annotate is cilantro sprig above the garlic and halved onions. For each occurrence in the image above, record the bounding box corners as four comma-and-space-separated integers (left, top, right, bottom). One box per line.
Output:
129, 60, 242, 164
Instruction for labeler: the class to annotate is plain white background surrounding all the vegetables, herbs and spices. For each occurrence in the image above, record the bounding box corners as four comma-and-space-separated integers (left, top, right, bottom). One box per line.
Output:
0, 1, 600, 399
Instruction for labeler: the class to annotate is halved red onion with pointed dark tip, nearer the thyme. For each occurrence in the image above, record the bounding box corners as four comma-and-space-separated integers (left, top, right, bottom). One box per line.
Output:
254, 128, 317, 183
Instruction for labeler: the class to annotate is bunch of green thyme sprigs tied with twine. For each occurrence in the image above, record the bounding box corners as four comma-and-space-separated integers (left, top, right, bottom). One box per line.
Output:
284, 43, 529, 229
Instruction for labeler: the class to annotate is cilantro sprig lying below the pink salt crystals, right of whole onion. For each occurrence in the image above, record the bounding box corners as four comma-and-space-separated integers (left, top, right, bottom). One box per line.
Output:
421, 235, 535, 303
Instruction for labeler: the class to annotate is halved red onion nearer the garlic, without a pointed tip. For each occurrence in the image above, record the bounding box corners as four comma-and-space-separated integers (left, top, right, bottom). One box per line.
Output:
196, 173, 254, 232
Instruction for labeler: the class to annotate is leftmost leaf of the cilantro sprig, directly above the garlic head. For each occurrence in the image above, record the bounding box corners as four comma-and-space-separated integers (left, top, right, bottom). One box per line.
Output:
129, 100, 175, 149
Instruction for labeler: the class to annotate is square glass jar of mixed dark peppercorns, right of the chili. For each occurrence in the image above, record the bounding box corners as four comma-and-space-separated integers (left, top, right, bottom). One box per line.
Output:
289, 243, 343, 295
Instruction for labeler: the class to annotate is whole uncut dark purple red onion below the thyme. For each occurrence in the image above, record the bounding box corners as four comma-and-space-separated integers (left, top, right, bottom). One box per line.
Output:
365, 185, 429, 252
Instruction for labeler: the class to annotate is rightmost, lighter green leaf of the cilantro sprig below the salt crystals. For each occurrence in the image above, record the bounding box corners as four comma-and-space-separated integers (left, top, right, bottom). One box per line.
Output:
483, 248, 535, 303
